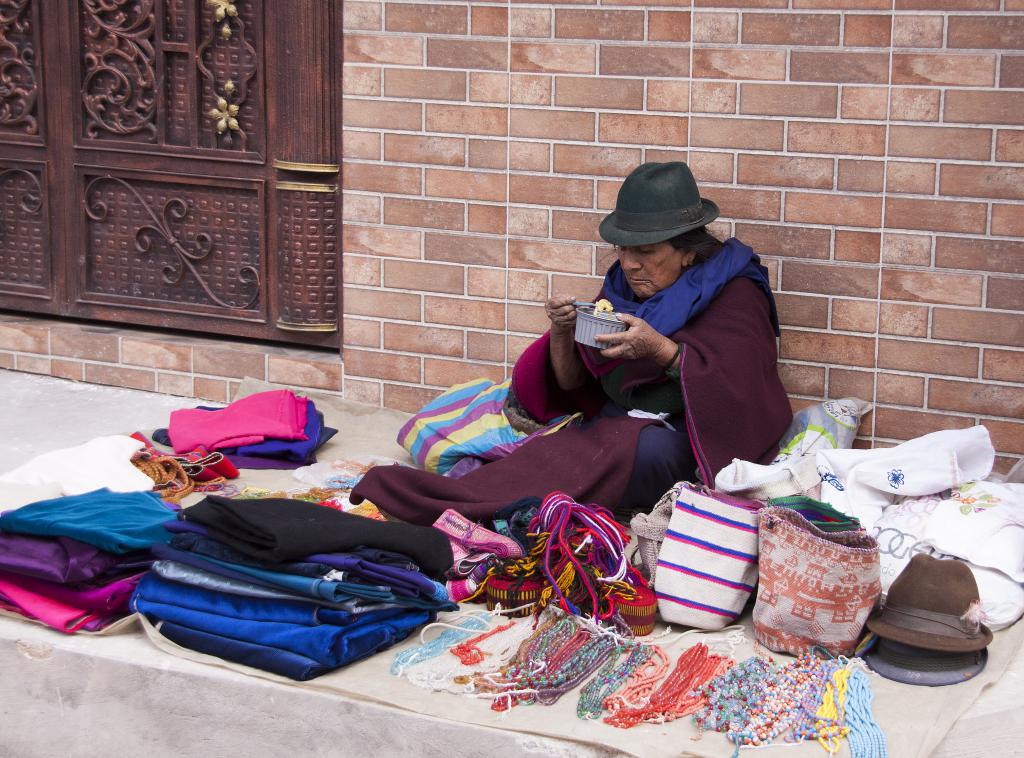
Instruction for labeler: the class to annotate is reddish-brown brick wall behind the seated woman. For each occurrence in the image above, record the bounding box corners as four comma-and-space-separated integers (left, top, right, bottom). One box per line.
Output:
343, 0, 1024, 470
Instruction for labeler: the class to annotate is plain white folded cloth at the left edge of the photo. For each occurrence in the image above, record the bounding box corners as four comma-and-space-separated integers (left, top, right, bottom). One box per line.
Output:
0, 434, 153, 505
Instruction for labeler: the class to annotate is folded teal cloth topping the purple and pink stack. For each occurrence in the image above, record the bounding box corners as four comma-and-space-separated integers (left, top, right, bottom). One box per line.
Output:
0, 488, 173, 553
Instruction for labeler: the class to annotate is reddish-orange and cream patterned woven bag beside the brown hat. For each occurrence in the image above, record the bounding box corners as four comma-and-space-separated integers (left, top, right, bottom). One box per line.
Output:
754, 508, 882, 656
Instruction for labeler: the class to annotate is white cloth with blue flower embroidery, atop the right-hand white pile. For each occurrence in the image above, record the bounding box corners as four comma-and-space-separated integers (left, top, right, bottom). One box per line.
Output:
815, 426, 995, 531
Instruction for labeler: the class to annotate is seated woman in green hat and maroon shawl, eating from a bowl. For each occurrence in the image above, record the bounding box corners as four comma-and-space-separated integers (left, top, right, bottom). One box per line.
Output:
352, 162, 792, 523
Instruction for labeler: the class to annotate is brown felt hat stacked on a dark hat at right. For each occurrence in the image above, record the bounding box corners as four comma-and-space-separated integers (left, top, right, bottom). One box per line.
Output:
867, 553, 992, 652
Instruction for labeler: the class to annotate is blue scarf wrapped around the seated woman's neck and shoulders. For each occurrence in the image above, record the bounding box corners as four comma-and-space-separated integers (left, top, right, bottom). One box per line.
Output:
602, 238, 779, 337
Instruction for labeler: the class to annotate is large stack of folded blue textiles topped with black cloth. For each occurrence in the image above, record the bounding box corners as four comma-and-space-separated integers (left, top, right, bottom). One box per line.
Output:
132, 496, 458, 680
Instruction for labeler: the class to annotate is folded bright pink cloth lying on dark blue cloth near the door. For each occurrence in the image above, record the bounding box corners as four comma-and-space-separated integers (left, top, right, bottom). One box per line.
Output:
167, 389, 306, 454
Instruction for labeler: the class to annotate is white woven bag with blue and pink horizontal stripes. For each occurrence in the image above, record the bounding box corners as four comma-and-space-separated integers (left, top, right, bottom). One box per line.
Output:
654, 485, 762, 629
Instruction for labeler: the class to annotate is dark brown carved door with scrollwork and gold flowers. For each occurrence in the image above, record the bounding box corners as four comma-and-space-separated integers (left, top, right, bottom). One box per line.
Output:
0, 0, 341, 345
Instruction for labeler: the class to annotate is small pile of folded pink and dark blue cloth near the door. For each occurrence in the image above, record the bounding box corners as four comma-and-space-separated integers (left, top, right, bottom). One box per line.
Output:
153, 389, 338, 469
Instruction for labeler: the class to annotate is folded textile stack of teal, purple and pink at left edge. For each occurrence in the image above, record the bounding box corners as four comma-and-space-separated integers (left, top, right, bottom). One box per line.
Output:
0, 490, 172, 634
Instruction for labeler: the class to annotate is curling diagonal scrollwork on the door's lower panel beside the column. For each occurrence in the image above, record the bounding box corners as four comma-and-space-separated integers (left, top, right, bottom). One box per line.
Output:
85, 175, 260, 309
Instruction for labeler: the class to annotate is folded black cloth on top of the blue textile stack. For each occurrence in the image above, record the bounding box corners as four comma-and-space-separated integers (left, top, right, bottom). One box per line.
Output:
181, 495, 453, 578
